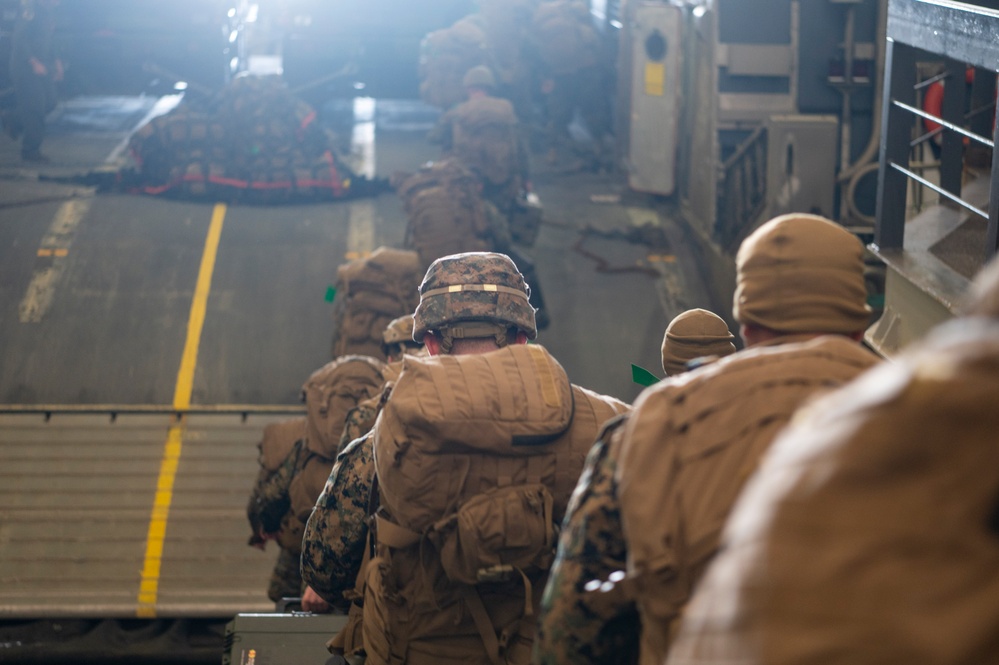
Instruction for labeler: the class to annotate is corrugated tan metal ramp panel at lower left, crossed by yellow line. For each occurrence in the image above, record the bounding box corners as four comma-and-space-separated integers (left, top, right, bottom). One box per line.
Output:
0, 414, 290, 618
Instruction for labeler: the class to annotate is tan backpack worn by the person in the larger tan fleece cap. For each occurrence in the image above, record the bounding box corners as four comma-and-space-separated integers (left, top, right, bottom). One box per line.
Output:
617, 335, 879, 664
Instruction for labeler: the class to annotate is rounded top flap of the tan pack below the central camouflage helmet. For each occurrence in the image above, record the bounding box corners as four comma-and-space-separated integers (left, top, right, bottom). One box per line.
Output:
385, 345, 574, 455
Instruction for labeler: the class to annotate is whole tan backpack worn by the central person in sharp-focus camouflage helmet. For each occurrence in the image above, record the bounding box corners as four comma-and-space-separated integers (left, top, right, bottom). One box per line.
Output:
364, 345, 627, 664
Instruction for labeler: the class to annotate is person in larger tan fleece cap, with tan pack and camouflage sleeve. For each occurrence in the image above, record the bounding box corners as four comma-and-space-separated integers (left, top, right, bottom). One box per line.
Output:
537, 215, 877, 665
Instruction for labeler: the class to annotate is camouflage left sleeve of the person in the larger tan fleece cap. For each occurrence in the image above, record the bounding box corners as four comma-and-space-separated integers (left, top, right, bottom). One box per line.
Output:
533, 416, 639, 665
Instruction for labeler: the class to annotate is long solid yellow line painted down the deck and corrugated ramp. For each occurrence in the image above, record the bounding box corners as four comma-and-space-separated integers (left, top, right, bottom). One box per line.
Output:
136, 203, 226, 618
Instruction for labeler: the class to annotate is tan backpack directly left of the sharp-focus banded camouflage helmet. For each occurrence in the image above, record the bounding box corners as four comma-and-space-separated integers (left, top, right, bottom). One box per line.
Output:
332, 247, 424, 360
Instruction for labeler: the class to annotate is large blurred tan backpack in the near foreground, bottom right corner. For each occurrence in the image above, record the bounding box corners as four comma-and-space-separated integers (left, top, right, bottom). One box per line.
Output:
669, 318, 999, 665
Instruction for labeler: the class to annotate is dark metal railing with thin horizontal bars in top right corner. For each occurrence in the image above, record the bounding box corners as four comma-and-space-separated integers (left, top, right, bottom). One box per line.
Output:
874, 0, 999, 261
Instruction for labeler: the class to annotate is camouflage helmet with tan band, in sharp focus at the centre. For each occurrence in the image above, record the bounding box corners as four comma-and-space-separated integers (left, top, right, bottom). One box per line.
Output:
413, 252, 538, 342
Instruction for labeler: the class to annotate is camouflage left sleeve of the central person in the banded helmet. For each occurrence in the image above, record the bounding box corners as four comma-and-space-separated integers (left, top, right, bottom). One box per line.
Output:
302, 436, 375, 604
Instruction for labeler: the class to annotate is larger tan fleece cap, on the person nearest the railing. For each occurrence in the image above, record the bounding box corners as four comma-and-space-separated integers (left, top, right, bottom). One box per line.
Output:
732, 213, 870, 334
